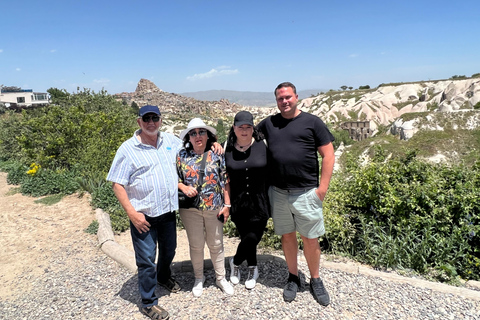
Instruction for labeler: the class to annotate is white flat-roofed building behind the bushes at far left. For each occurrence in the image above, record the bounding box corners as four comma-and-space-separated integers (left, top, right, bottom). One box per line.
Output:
0, 88, 50, 109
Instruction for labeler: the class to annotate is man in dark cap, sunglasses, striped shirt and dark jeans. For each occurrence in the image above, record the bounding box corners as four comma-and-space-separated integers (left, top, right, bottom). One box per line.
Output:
107, 105, 182, 319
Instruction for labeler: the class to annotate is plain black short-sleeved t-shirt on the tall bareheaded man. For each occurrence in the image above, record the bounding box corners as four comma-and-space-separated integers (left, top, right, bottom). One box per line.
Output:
258, 112, 334, 190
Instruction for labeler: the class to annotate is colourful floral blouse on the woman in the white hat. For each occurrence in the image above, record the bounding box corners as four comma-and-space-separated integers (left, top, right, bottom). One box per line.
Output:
177, 149, 228, 210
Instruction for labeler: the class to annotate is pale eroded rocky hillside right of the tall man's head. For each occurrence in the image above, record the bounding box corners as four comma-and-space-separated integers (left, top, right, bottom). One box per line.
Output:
302, 78, 480, 135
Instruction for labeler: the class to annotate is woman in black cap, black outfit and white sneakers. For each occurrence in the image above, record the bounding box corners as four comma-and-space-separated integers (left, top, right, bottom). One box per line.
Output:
225, 111, 270, 289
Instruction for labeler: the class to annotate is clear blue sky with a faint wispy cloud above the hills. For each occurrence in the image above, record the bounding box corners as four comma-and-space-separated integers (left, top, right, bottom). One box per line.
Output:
0, 0, 480, 94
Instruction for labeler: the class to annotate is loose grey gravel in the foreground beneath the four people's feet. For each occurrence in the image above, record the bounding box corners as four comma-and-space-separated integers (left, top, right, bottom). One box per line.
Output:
0, 237, 480, 319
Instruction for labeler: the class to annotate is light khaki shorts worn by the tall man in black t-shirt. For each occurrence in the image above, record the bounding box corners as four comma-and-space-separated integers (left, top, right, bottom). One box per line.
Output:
268, 186, 325, 239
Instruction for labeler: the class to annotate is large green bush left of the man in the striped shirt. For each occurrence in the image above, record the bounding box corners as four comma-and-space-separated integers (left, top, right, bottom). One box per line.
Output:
0, 89, 137, 174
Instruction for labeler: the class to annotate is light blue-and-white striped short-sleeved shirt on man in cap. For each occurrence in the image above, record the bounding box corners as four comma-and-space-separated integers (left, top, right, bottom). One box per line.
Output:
107, 130, 182, 217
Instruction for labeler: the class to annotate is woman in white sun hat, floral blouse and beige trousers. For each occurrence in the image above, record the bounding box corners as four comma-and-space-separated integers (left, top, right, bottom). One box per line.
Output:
177, 118, 234, 297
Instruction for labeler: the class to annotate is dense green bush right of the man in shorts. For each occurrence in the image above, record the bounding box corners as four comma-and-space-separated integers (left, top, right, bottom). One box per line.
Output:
325, 148, 480, 280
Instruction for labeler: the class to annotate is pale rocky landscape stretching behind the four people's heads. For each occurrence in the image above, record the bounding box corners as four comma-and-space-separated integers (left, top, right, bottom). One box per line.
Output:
115, 74, 480, 139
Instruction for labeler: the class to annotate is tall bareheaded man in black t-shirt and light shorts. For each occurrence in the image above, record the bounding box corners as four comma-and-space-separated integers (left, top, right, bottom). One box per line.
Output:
258, 82, 335, 306
